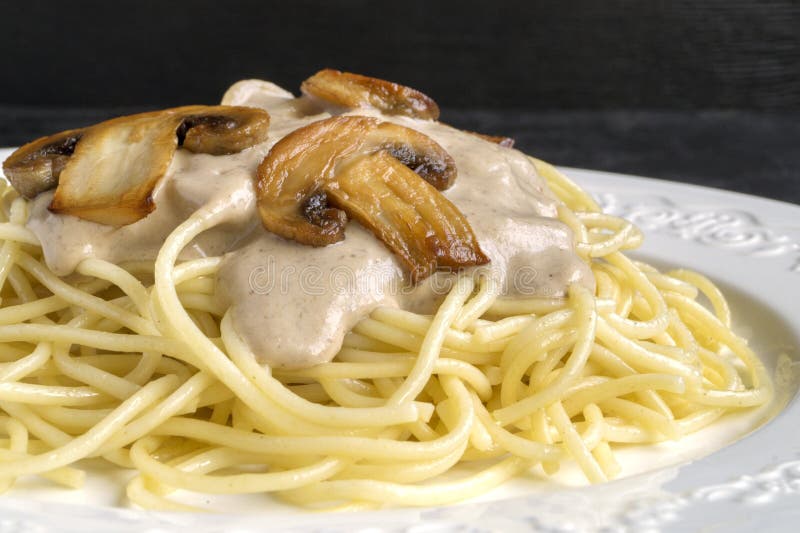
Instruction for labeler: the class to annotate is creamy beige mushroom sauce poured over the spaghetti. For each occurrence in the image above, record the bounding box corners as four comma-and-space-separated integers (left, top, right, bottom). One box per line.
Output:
28, 82, 594, 368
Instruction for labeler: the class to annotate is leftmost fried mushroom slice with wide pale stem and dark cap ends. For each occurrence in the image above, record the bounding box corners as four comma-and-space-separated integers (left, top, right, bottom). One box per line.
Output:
3, 106, 269, 226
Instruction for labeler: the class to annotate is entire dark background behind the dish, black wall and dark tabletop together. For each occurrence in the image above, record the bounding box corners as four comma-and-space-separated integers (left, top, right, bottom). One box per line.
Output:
0, 0, 800, 202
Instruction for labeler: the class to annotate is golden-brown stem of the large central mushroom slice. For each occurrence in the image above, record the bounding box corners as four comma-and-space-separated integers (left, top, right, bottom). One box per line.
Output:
327, 151, 489, 282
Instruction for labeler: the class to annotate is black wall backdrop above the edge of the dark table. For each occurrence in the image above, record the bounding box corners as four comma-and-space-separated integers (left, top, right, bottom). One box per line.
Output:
0, 0, 800, 109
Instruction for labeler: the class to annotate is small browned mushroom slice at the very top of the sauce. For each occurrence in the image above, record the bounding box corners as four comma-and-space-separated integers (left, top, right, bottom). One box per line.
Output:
300, 68, 439, 120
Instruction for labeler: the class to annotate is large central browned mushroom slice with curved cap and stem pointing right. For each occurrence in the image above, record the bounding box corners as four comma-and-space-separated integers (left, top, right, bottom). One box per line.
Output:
256, 115, 489, 282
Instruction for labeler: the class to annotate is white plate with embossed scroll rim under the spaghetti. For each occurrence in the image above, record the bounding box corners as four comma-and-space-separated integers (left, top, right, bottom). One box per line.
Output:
0, 150, 800, 533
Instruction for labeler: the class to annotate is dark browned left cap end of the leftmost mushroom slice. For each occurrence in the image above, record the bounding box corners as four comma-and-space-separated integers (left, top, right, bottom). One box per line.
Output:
3, 129, 84, 199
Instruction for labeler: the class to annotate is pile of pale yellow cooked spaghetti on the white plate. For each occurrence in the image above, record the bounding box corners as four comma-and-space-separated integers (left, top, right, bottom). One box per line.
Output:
0, 161, 772, 509
